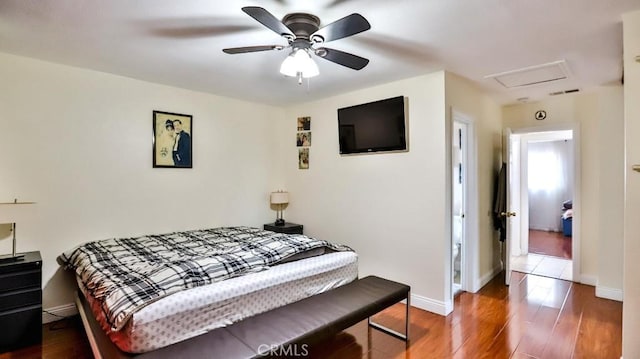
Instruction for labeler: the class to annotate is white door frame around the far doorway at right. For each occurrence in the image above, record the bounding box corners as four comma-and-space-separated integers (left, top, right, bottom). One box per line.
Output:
505, 122, 582, 282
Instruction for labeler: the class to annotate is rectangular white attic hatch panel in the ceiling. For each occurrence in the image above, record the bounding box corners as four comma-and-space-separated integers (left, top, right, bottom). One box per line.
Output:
484, 60, 569, 88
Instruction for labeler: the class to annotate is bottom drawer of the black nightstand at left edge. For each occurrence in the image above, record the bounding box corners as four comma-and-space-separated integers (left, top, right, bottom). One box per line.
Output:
0, 305, 42, 353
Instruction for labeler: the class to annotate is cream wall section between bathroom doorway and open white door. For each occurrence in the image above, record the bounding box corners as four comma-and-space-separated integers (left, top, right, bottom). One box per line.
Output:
446, 72, 502, 291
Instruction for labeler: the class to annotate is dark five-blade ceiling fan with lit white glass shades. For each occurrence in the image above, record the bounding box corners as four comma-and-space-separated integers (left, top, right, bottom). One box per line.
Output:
222, 6, 371, 84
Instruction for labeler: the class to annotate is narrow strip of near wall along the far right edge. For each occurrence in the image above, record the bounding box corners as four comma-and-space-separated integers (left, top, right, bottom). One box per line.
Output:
622, 11, 640, 358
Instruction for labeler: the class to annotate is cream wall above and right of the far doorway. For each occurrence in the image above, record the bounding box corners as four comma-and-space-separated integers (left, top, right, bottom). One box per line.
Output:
503, 86, 623, 296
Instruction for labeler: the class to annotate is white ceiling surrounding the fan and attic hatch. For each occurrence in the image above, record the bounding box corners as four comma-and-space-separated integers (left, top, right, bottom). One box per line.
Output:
0, 0, 640, 105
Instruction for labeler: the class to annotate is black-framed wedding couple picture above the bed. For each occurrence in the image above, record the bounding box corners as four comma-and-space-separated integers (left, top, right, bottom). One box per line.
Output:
153, 111, 193, 168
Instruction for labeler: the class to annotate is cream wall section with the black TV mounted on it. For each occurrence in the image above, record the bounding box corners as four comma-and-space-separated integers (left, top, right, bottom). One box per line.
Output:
280, 72, 448, 312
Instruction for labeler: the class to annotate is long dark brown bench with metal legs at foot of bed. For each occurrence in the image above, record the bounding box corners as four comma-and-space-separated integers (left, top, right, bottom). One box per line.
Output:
78, 276, 410, 359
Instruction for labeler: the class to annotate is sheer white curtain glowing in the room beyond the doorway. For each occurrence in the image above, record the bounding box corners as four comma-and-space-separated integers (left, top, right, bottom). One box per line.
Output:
528, 140, 573, 232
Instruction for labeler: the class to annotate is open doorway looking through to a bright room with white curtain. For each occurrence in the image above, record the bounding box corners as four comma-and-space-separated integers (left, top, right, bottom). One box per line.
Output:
508, 129, 579, 280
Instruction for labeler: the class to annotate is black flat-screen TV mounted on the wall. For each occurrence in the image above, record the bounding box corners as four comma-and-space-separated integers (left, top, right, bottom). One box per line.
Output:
338, 96, 407, 154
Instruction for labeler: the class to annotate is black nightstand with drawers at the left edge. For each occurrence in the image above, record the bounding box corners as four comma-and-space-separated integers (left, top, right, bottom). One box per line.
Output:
0, 252, 42, 353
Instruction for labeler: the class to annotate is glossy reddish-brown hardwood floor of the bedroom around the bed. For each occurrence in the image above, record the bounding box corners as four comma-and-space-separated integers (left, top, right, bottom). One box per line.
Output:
0, 272, 622, 359
